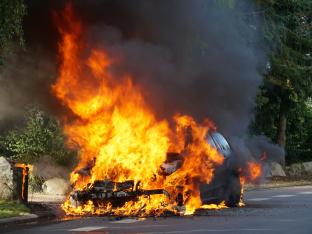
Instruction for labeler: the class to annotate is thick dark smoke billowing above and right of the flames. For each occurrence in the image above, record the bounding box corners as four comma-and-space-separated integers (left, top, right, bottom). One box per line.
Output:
74, 0, 264, 135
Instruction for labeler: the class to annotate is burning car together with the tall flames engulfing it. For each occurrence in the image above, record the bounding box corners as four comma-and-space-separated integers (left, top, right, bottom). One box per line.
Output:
52, 5, 261, 216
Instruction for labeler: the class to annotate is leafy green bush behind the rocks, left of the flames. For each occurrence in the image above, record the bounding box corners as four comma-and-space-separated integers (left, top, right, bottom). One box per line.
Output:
0, 110, 75, 165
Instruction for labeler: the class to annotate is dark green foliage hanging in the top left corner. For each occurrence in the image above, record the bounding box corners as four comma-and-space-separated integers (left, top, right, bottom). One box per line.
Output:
0, 0, 26, 61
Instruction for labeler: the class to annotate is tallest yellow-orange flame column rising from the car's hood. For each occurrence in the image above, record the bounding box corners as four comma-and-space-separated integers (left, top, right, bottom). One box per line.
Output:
53, 6, 169, 192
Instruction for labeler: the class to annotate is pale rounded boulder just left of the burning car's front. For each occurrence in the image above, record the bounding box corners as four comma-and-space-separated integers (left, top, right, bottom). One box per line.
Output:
42, 177, 70, 195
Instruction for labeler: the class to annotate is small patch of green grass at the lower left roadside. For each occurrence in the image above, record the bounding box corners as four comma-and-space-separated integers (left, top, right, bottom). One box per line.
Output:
0, 200, 29, 219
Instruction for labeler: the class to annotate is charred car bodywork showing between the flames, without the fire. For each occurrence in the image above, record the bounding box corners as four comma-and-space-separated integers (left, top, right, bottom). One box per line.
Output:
70, 131, 241, 207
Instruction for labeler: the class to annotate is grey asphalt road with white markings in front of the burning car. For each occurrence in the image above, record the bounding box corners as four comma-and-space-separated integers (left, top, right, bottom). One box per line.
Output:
0, 186, 312, 234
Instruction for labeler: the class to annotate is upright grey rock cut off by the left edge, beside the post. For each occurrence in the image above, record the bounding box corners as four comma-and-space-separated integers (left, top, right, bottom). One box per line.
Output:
0, 157, 13, 199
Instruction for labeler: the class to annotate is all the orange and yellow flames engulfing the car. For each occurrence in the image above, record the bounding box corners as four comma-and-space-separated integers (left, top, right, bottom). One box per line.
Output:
52, 5, 260, 215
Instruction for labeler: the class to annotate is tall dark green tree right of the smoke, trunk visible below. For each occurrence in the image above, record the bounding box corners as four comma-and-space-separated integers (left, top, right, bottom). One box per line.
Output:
255, 0, 312, 164
